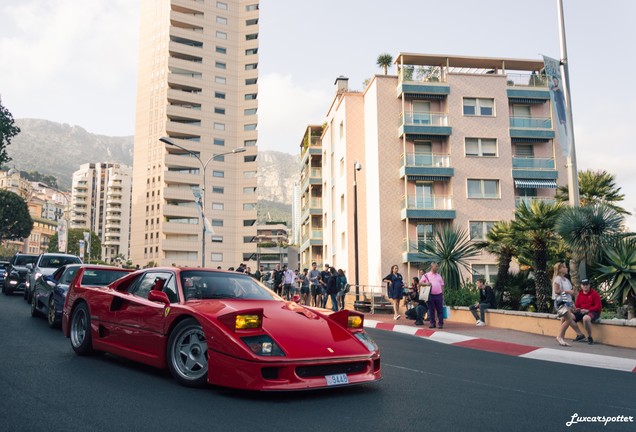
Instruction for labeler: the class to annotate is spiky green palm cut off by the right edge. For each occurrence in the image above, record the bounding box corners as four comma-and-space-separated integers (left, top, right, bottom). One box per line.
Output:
594, 236, 636, 319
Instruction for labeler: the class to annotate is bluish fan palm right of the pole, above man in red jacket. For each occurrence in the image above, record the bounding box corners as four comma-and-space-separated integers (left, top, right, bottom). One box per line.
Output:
555, 204, 623, 287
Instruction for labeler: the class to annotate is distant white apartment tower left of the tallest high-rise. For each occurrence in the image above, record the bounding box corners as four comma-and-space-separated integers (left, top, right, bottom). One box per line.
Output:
70, 162, 132, 263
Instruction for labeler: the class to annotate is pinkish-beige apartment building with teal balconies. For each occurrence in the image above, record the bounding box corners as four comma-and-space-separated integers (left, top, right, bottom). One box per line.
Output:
301, 53, 567, 287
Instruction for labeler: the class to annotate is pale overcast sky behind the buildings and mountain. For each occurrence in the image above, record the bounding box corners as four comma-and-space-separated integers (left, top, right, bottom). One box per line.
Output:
0, 0, 636, 227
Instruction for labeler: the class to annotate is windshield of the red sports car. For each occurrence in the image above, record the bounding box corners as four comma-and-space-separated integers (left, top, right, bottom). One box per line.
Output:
180, 270, 279, 300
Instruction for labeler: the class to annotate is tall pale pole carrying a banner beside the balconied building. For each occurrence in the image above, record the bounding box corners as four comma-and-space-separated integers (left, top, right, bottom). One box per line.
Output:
557, 0, 581, 207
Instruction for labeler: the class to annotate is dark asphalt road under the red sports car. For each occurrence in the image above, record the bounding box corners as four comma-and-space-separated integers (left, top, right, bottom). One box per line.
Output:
0, 295, 636, 432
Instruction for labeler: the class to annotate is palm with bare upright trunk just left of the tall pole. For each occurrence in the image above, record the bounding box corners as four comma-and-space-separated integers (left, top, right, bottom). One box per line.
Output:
512, 200, 561, 312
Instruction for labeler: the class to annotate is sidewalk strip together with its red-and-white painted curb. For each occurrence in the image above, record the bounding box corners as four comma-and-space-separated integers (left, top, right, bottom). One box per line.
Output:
364, 313, 636, 372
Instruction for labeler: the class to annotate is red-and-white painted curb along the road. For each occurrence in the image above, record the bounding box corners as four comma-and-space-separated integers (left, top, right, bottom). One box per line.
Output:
364, 319, 636, 373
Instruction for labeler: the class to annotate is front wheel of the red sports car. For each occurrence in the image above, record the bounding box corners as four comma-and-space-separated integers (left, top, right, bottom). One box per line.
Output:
166, 318, 208, 387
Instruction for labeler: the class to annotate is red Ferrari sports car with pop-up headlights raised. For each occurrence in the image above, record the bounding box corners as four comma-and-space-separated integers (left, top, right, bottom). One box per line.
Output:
62, 267, 382, 390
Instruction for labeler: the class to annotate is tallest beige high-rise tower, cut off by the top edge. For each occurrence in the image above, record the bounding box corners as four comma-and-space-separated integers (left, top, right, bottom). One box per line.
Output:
131, 0, 259, 268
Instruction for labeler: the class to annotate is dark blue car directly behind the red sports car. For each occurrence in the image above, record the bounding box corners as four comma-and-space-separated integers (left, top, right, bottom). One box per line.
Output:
31, 264, 132, 328
